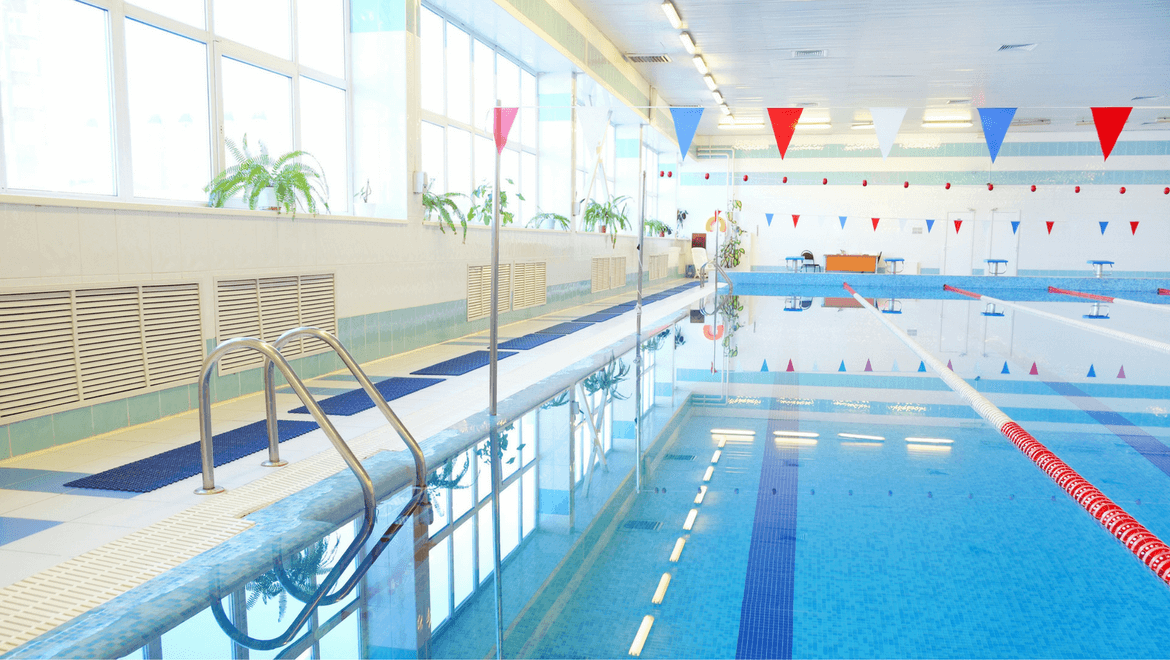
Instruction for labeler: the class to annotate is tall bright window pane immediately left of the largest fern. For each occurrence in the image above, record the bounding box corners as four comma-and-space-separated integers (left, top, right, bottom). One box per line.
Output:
126, 21, 212, 201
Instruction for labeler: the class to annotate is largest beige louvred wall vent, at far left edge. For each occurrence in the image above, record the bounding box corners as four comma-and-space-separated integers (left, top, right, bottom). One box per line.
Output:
0, 282, 204, 421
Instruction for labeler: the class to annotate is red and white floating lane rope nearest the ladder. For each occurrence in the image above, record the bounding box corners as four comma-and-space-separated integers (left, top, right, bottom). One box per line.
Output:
845, 283, 1170, 584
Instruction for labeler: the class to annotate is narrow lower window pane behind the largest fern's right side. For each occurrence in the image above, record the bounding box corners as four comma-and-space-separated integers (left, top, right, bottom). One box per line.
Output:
301, 77, 341, 213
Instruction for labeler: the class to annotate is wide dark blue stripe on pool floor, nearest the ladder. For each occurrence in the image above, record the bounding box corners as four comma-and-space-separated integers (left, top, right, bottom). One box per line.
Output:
735, 411, 800, 660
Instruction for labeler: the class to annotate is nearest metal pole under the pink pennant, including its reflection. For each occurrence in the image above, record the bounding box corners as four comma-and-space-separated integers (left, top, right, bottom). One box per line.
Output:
488, 99, 504, 659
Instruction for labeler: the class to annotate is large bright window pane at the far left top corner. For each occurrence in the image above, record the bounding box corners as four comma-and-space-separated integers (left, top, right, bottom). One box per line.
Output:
0, 0, 114, 194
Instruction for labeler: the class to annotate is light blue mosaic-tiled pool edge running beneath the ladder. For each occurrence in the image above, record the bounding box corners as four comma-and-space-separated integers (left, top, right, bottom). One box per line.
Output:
0, 306, 687, 658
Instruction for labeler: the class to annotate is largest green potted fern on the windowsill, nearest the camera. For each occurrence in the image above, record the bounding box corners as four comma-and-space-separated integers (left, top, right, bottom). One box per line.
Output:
204, 135, 329, 218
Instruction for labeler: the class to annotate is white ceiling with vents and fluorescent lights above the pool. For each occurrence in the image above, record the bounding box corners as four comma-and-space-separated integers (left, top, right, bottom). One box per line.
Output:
563, 0, 1170, 135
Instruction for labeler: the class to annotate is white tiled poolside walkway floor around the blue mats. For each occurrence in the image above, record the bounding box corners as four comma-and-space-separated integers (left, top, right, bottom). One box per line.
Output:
0, 281, 711, 586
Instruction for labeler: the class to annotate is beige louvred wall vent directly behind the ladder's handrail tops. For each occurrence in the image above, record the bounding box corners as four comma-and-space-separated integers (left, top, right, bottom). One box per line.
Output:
215, 274, 337, 376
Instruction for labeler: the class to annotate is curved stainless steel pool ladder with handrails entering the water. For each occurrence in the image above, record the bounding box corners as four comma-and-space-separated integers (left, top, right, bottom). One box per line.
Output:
195, 328, 434, 651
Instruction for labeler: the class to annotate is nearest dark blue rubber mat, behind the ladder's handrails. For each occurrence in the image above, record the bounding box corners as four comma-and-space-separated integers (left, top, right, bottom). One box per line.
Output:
66, 419, 317, 493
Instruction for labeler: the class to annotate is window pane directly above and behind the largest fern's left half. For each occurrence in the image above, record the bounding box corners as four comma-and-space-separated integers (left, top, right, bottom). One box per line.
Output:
221, 57, 293, 161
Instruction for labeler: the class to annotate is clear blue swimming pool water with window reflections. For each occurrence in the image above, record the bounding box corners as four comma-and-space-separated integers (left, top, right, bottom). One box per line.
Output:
12, 276, 1170, 659
